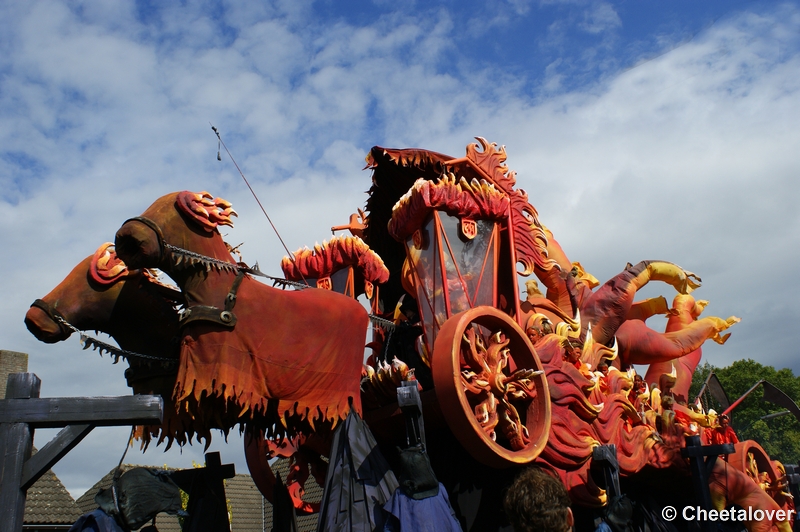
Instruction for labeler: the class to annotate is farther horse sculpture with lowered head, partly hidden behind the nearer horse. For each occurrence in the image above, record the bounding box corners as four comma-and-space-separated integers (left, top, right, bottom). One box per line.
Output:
25, 243, 200, 449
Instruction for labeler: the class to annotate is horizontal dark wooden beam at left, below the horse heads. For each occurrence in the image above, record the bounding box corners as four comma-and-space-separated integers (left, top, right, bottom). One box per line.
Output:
0, 394, 164, 428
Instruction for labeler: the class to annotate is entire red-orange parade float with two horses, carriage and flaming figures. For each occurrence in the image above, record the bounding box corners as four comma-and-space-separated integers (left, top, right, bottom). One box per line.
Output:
26, 138, 793, 531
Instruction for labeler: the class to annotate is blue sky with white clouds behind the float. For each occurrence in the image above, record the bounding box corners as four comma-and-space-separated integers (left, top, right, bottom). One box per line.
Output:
0, 0, 800, 494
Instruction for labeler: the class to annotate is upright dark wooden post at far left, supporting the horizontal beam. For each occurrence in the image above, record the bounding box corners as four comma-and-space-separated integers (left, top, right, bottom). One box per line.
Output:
0, 373, 42, 531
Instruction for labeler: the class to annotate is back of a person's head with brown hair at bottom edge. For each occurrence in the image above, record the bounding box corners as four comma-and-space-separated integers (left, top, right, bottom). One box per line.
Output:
503, 467, 575, 532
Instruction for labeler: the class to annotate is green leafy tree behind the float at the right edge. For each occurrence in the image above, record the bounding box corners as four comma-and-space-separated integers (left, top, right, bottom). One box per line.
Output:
689, 359, 800, 464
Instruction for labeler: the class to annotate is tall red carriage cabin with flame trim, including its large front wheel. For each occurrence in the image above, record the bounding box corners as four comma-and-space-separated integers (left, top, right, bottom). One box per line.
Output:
326, 139, 550, 467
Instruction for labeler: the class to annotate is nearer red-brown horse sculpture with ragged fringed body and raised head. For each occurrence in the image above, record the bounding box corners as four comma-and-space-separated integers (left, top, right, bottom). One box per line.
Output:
116, 192, 369, 510
